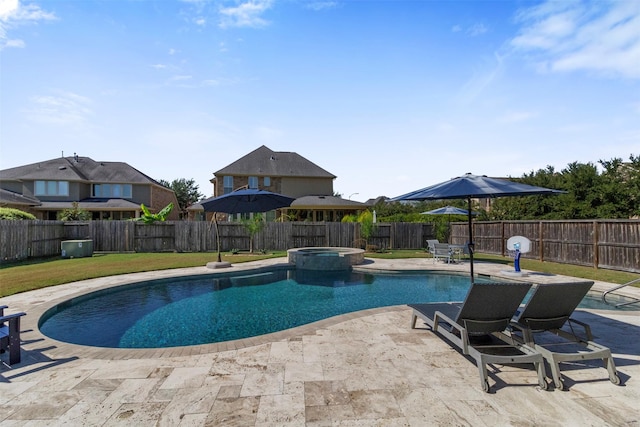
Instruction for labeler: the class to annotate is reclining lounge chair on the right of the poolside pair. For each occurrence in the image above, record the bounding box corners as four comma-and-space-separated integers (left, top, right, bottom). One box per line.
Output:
511, 281, 620, 390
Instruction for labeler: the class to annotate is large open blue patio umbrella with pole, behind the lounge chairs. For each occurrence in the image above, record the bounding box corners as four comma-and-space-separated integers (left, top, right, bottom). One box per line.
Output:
391, 173, 564, 283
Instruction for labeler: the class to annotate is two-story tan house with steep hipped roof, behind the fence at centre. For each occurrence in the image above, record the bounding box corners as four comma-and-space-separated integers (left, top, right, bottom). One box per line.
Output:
189, 145, 367, 221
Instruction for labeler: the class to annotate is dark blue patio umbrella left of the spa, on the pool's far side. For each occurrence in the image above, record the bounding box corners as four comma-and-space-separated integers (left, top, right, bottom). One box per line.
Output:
199, 188, 295, 263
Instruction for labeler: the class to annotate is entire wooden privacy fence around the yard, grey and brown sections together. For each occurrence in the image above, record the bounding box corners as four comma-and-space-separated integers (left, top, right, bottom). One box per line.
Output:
0, 220, 640, 272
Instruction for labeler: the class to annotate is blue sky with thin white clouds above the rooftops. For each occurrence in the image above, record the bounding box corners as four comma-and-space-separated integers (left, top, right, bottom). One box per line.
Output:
0, 0, 640, 201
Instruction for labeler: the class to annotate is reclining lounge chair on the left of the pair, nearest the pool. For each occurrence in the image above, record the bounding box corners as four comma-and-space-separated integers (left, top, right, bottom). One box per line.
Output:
409, 283, 548, 393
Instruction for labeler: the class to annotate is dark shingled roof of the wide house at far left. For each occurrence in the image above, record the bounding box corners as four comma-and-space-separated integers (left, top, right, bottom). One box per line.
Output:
0, 156, 165, 185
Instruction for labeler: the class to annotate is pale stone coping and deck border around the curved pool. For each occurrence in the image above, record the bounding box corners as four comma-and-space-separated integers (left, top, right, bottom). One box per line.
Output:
7, 258, 640, 360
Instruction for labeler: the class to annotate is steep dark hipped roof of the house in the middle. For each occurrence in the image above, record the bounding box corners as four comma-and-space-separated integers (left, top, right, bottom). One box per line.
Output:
214, 145, 336, 179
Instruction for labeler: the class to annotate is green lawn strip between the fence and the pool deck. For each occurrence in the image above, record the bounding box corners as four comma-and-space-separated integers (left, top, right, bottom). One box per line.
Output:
0, 250, 638, 297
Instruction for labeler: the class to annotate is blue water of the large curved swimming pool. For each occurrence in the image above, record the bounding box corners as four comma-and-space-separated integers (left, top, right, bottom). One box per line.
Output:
40, 270, 624, 348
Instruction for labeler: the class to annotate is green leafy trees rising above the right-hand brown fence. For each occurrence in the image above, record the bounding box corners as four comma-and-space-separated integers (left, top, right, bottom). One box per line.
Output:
374, 155, 640, 222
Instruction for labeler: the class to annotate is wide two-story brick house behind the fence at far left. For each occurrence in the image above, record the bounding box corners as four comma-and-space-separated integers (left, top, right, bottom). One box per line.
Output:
0, 155, 179, 220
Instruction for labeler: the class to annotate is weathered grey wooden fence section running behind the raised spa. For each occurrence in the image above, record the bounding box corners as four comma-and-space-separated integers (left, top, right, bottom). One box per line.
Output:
0, 221, 433, 262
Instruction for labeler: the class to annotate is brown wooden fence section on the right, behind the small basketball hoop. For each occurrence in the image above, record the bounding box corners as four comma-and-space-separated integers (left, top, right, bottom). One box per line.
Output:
451, 220, 640, 273
